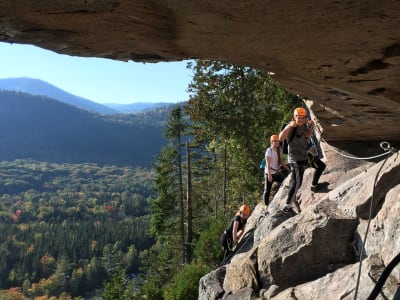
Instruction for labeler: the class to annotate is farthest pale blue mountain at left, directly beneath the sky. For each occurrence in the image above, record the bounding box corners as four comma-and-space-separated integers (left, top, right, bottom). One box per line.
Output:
0, 78, 117, 114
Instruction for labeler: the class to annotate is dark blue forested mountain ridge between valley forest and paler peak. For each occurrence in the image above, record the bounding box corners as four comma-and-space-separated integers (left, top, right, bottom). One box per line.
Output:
0, 91, 169, 167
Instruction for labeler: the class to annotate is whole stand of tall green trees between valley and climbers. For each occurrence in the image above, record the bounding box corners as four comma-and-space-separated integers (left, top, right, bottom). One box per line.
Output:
140, 61, 301, 299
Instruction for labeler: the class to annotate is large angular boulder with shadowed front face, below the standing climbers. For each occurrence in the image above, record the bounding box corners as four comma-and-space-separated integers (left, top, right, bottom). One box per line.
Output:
257, 201, 358, 292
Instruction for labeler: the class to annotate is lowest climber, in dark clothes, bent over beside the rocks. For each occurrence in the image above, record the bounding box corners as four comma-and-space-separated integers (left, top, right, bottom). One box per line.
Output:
219, 204, 250, 262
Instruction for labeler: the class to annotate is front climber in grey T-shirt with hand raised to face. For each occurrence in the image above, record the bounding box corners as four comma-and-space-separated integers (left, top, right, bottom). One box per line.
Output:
279, 107, 314, 212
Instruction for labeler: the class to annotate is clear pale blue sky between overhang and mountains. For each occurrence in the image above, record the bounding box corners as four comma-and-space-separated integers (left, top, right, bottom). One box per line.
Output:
0, 42, 192, 104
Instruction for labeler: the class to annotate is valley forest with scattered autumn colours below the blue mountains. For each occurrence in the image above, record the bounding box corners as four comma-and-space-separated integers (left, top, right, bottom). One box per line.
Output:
0, 160, 154, 299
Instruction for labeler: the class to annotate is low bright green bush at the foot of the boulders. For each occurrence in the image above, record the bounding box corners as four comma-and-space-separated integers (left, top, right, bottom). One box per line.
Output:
165, 264, 211, 300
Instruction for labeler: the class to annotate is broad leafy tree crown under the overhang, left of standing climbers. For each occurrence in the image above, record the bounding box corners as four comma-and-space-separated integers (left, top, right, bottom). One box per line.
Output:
185, 61, 300, 209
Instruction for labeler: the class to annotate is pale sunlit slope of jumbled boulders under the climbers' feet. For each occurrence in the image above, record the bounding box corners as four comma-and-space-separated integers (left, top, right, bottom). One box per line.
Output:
199, 145, 400, 300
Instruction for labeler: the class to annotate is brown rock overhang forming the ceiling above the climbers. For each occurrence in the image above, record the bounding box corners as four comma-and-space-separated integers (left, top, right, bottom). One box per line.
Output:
0, 0, 400, 141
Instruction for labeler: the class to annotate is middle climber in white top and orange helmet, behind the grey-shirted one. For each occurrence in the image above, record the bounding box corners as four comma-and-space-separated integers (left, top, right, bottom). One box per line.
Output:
263, 134, 290, 206
